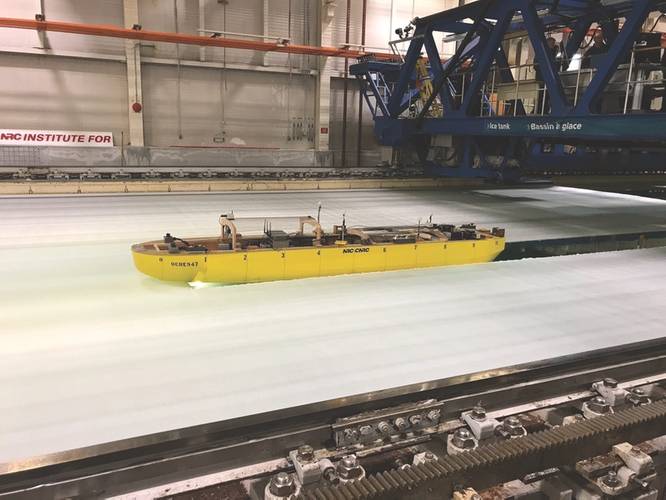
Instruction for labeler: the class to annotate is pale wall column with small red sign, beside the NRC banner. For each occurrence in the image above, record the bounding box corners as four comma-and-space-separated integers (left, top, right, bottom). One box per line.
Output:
123, 0, 144, 146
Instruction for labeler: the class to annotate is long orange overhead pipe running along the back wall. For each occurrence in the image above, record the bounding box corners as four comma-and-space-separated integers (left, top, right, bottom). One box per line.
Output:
0, 17, 396, 61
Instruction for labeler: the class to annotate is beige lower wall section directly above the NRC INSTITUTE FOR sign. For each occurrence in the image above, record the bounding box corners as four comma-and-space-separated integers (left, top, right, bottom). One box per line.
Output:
0, 54, 128, 144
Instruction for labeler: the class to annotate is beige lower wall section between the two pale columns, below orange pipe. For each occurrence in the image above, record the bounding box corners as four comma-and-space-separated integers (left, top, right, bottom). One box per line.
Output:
143, 64, 314, 149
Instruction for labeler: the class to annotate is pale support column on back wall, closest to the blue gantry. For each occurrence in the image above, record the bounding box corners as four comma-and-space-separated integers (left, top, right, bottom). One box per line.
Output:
315, 0, 335, 151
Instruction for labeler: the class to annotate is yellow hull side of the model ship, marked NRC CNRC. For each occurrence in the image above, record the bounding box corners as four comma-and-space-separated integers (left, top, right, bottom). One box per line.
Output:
132, 237, 505, 284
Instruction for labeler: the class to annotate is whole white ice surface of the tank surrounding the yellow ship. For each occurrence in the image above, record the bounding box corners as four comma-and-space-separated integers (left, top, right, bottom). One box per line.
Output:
0, 188, 666, 462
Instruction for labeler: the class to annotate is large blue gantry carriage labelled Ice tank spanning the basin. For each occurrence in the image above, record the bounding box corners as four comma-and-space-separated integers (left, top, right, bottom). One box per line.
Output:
350, 0, 666, 178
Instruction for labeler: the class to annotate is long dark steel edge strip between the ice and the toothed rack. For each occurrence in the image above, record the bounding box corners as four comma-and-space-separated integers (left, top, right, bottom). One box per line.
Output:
0, 338, 666, 498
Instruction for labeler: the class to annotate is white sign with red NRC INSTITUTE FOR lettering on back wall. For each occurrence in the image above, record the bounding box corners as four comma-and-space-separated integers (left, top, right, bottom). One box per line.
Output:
0, 129, 113, 148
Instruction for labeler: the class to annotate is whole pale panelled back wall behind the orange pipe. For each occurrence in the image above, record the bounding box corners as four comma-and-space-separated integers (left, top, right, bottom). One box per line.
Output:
0, 0, 458, 158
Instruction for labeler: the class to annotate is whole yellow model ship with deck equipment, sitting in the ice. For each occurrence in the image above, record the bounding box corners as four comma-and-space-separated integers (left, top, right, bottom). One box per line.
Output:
132, 215, 505, 284
